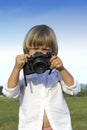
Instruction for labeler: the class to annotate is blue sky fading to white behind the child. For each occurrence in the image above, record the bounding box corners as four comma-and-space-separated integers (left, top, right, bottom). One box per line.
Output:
0, 0, 87, 85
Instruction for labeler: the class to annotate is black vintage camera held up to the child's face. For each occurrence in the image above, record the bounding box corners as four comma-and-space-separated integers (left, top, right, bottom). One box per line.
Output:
23, 52, 53, 86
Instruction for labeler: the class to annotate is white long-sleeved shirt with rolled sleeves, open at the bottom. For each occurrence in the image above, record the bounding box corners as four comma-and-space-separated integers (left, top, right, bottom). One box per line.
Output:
3, 70, 80, 130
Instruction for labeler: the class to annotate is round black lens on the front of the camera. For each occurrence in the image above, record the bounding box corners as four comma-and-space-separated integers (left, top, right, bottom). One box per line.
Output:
33, 58, 47, 74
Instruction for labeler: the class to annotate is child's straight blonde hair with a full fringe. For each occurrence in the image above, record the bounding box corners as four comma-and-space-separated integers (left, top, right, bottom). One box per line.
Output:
23, 25, 58, 55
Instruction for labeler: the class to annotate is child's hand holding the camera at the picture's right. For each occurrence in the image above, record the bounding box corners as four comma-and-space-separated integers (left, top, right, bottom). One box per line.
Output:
50, 55, 63, 71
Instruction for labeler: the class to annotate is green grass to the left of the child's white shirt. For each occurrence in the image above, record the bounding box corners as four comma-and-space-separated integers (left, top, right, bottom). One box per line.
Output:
0, 97, 19, 130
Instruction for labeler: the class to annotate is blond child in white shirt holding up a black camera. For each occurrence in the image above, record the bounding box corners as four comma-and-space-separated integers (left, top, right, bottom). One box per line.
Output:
3, 25, 80, 130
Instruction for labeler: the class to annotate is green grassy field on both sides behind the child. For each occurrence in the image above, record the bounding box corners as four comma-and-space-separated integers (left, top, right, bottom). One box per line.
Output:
0, 91, 87, 130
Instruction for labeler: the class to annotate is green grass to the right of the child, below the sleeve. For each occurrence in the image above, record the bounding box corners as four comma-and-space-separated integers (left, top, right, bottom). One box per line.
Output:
65, 91, 87, 130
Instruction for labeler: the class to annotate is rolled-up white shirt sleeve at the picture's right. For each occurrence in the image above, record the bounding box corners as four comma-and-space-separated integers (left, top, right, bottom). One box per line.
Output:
60, 79, 81, 95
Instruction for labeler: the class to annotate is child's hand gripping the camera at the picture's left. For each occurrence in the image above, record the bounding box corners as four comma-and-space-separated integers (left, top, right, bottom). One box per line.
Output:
15, 54, 29, 70
